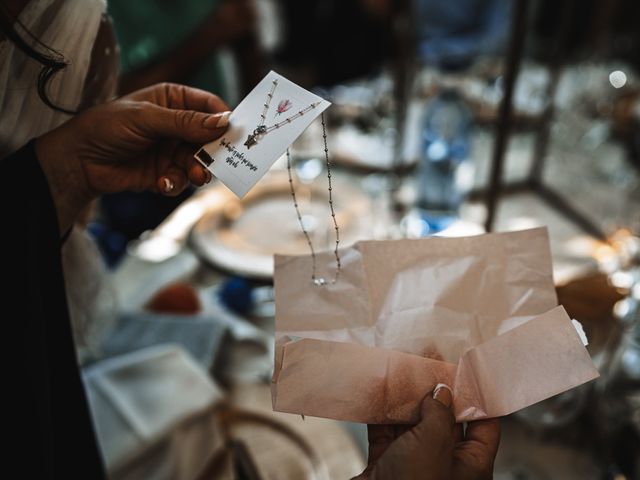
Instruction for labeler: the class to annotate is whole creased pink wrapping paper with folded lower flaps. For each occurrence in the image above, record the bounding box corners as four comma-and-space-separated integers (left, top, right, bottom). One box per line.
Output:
272, 229, 598, 423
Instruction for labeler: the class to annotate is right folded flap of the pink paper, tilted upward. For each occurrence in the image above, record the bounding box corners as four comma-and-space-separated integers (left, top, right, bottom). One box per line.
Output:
461, 307, 598, 417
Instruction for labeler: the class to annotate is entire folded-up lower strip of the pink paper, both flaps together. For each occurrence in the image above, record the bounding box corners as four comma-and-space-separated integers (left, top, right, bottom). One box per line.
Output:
272, 307, 598, 423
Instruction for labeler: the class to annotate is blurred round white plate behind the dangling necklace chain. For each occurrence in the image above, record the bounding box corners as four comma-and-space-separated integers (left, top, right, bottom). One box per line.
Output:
190, 171, 373, 279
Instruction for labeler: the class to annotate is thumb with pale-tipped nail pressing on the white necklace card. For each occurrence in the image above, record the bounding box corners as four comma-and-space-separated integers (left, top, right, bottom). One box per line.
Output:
145, 103, 231, 143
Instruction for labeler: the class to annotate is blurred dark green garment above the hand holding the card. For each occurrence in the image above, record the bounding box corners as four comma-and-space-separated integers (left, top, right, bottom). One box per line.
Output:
108, 0, 225, 97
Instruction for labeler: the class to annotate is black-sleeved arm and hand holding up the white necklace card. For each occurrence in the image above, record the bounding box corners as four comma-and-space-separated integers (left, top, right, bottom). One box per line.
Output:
0, 85, 227, 479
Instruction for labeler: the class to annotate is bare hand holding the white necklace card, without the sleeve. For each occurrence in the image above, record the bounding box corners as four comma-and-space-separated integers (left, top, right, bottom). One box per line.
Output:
36, 84, 229, 232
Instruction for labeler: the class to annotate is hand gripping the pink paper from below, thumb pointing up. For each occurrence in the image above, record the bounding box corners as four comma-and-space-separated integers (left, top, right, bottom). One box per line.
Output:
357, 386, 500, 480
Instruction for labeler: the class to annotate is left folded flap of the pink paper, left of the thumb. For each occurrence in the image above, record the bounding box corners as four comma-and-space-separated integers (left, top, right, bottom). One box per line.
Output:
272, 339, 456, 423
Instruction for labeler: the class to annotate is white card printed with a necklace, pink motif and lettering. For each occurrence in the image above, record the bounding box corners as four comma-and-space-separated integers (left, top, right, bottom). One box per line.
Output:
195, 71, 331, 197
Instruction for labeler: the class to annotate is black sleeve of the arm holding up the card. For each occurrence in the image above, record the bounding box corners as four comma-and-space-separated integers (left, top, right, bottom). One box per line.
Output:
0, 141, 105, 480
